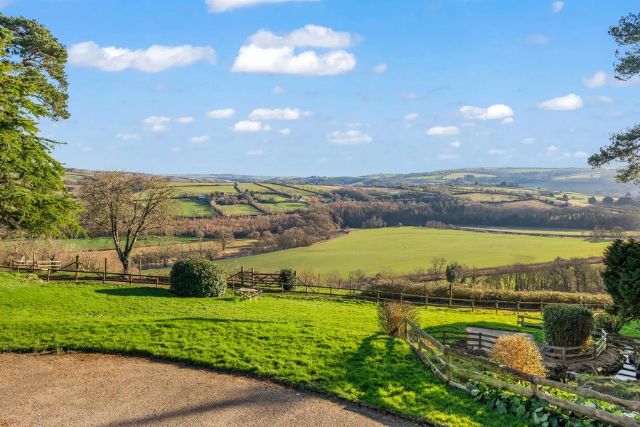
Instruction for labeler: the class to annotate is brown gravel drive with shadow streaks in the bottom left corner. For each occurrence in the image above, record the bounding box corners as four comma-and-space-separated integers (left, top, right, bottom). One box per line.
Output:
0, 354, 414, 427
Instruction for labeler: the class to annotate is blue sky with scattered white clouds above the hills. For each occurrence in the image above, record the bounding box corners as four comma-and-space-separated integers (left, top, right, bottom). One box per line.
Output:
0, 0, 640, 176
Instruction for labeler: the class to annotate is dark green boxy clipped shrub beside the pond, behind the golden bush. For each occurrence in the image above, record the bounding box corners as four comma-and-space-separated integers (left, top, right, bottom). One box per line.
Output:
544, 304, 593, 347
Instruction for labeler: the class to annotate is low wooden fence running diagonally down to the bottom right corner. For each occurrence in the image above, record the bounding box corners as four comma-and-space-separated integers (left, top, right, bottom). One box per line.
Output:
404, 319, 640, 427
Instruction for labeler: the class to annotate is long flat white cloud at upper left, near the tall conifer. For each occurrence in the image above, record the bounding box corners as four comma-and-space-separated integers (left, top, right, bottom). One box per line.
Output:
69, 41, 216, 73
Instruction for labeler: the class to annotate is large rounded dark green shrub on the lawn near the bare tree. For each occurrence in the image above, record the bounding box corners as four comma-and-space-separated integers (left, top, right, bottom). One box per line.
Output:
170, 258, 227, 298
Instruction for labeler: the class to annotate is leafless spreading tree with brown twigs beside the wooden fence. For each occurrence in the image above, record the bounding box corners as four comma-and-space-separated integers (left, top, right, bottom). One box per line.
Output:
80, 172, 173, 273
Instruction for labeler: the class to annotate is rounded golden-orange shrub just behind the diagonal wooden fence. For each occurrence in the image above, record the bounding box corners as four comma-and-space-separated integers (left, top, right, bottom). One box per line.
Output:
491, 334, 545, 377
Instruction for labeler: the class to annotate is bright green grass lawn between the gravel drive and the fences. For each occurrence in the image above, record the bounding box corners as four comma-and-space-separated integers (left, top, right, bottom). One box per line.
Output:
0, 273, 536, 426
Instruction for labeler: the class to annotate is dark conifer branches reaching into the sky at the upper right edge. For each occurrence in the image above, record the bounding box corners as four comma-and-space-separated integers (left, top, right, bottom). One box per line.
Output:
589, 13, 640, 183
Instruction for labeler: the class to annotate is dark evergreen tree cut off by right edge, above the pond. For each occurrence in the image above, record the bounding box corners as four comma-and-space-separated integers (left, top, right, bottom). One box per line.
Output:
602, 239, 640, 321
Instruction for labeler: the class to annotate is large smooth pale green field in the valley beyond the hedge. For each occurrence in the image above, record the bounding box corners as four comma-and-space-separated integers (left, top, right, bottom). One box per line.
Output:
224, 227, 609, 277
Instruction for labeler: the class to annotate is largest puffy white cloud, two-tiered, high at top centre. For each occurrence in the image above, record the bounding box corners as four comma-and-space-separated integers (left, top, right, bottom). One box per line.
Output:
231, 25, 356, 76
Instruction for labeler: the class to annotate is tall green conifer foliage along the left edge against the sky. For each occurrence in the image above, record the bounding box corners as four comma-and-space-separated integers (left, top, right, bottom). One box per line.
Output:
0, 14, 77, 235
